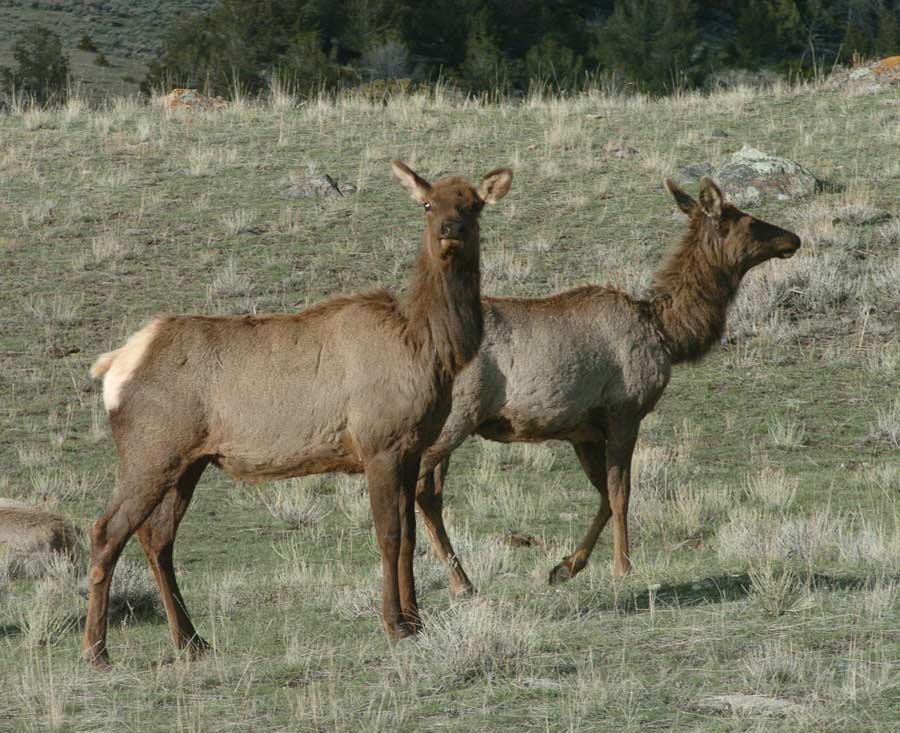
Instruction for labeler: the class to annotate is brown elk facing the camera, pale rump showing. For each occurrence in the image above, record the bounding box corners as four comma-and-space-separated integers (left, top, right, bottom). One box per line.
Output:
83, 161, 512, 667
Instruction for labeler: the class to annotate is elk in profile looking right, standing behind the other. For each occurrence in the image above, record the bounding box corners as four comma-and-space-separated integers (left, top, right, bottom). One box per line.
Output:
416, 178, 800, 595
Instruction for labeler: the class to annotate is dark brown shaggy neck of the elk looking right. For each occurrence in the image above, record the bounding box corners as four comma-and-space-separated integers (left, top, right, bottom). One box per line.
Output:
647, 211, 741, 364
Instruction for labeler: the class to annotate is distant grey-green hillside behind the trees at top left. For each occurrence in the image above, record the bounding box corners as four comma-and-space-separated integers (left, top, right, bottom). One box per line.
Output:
0, 0, 213, 95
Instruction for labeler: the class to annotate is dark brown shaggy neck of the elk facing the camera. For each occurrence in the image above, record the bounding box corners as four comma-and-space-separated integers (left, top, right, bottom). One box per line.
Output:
403, 231, 483, 377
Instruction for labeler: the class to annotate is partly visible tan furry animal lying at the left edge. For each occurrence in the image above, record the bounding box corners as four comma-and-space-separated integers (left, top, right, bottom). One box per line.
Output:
0, 500, 81, 576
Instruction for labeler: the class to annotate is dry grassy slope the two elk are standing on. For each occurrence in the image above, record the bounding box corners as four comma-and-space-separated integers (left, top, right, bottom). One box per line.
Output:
0, 87, 900, 731
